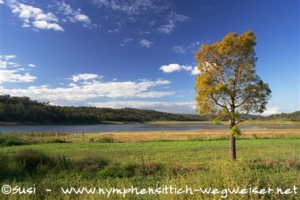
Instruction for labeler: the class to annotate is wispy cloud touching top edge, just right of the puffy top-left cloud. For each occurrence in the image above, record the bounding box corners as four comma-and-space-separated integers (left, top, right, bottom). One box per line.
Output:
56, 1, 91, 27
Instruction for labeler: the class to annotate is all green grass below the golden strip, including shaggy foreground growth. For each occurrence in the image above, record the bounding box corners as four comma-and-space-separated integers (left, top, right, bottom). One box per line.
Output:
0, 132, 300, 200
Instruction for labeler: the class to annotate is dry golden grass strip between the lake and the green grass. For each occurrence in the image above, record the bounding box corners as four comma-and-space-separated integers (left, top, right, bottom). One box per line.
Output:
82, 129, 300, 142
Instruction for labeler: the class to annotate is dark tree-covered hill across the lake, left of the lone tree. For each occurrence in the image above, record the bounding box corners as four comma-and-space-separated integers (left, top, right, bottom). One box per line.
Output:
0, 95, 207, 124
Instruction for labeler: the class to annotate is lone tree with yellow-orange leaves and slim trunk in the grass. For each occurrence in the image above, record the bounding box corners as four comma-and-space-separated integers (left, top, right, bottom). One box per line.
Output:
195, 30, 271, 160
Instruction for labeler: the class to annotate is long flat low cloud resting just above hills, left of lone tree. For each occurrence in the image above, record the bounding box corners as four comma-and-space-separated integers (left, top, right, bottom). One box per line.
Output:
89, 101, 196, 114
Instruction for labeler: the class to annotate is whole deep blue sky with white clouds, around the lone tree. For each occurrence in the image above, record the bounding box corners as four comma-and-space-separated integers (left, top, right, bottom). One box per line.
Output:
0, 0, 300, 114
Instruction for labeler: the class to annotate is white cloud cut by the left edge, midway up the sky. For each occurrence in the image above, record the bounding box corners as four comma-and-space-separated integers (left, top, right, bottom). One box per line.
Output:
0, 55, 36, 84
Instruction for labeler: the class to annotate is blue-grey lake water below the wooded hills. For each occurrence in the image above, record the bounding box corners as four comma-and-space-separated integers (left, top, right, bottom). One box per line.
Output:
0, 122, 300, 133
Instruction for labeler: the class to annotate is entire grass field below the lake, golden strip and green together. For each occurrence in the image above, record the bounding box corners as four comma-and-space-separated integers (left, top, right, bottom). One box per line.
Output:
0, 129, 300, 200
